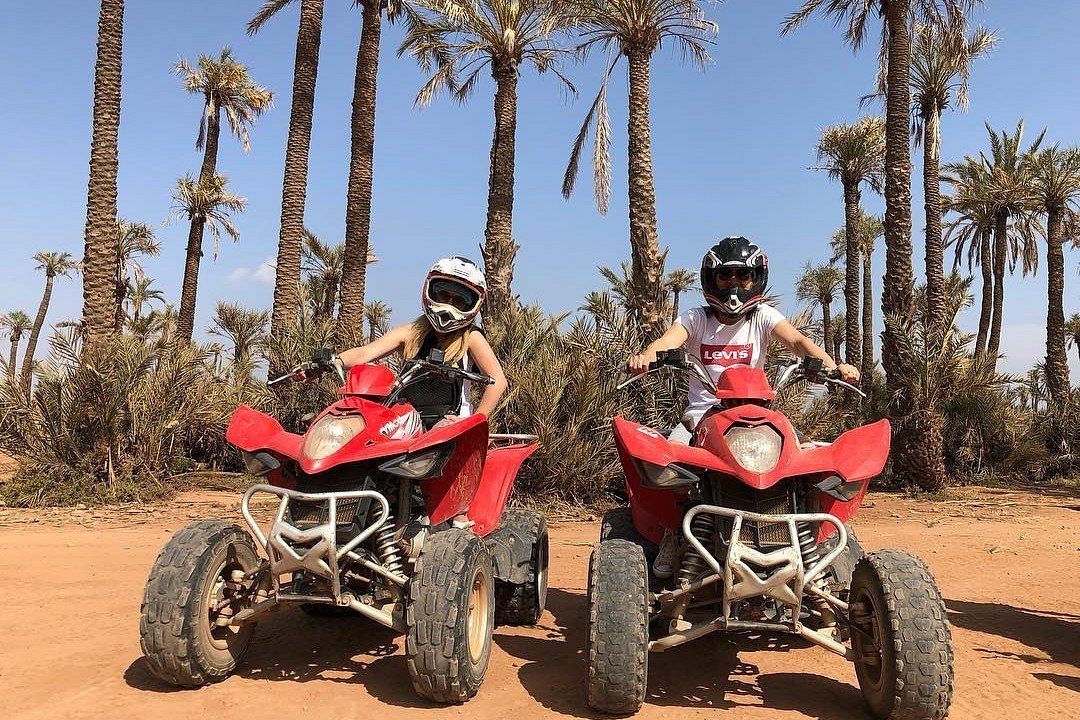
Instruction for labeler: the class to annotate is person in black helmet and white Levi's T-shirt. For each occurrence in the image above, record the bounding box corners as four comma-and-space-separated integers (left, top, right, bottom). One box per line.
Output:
629, 236, 859, 444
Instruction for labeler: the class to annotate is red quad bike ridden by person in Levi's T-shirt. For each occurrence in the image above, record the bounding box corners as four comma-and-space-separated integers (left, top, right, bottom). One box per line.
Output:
585, 350, 953, 720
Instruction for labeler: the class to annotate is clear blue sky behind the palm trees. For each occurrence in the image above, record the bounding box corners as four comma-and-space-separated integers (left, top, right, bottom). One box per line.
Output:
0, 0, 1080, 381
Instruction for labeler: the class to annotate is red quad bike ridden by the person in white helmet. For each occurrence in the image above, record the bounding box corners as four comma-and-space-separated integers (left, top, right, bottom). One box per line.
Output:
139, 350, 548, 703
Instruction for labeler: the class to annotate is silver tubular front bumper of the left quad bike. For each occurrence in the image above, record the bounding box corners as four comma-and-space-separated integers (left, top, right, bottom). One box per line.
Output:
232, 484, 408, 633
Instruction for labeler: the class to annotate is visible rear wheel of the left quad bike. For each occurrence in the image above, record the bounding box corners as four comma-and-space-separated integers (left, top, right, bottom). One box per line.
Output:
495, 510, 548, 625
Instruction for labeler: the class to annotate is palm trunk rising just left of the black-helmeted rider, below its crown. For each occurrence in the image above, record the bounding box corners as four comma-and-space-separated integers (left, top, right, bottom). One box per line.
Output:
624, 46, 665, 337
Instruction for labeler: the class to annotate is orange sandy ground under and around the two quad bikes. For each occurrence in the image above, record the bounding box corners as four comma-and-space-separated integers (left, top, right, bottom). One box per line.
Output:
0, 489, 1080, 720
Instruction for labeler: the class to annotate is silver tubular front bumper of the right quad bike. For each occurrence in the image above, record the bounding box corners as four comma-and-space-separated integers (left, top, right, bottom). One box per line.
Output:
649, 505, 853, 660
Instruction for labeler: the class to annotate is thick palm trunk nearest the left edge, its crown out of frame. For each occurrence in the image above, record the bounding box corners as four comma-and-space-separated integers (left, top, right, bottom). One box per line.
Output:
81, 0, 124, 351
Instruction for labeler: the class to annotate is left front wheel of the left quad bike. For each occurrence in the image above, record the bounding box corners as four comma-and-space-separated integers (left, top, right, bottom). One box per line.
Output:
139, 520, 259, 688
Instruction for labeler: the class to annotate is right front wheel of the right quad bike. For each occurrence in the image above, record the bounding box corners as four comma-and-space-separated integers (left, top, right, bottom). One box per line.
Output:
849, 551, 953, 720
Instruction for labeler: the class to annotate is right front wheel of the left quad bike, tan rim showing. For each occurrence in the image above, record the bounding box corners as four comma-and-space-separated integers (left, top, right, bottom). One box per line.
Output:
405, 529, 495, 703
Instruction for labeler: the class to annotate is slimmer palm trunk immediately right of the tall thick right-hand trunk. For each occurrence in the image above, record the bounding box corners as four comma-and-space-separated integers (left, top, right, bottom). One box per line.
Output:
921, 106, 945, 335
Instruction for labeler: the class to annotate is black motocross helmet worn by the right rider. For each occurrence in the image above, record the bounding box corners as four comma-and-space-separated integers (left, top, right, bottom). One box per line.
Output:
701, 235, 769, 320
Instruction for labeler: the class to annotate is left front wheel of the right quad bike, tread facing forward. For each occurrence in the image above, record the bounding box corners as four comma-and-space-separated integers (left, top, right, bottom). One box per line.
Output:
585, 540, 649, 715
